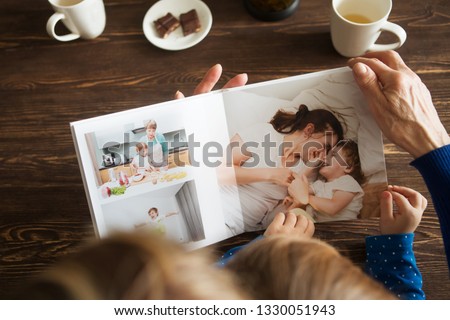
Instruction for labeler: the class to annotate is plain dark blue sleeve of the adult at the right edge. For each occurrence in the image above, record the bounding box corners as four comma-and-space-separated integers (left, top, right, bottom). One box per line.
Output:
411, 145, 450, 268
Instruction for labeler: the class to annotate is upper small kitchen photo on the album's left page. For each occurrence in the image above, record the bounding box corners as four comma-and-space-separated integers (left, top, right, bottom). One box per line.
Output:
86, 119, 191, 191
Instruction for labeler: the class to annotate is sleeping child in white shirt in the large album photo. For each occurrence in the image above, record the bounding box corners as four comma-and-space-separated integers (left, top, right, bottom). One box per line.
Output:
288, 140, 365, 222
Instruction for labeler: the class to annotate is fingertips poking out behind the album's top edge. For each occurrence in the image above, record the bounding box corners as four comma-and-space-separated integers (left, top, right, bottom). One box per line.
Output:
175, 64, 248, 99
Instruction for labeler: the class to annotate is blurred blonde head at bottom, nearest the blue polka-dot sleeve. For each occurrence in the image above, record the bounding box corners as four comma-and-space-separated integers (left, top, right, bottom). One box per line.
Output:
228, 236, 394, 300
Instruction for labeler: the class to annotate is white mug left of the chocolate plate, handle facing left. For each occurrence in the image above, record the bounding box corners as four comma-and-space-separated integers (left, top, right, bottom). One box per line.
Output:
47, 0, 106, 41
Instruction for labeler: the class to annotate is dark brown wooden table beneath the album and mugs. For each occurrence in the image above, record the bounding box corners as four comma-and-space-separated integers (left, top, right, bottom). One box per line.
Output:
0, 0, 450, 299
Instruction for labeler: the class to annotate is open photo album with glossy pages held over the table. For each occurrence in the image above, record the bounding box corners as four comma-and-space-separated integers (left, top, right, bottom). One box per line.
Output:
71, 68, 387, 249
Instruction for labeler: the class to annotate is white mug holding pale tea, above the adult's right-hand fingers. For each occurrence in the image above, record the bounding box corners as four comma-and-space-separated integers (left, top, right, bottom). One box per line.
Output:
330, 0, 406, 57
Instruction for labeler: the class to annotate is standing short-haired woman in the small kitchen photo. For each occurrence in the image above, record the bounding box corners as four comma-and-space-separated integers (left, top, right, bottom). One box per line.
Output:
139, 119, 169, 170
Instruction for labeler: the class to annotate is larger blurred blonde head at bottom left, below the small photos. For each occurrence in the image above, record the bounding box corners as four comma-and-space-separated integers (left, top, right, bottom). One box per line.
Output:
20, 232, 245, 299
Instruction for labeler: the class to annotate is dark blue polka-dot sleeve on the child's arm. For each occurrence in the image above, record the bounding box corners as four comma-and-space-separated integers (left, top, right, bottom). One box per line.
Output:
366, 233, 425, 300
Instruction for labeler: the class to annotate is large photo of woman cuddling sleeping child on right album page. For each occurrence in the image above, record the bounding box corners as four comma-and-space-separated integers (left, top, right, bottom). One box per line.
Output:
218, 72, 387, 235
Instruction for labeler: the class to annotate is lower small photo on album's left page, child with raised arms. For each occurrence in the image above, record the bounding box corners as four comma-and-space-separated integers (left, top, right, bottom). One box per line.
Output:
102, 180, 205, 243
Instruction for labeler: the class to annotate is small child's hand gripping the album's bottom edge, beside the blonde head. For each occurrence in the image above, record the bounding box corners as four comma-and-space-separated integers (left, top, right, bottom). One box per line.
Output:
264, 212, 315, 238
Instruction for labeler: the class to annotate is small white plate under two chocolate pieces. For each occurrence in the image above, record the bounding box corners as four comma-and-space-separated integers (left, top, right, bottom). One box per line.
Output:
142, 0, 212, 51
